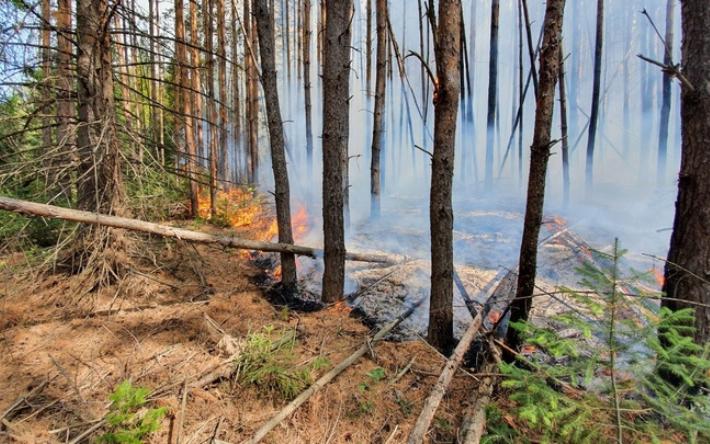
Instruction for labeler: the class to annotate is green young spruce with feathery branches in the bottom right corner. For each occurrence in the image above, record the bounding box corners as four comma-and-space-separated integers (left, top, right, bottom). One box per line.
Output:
485, 243, 710, 443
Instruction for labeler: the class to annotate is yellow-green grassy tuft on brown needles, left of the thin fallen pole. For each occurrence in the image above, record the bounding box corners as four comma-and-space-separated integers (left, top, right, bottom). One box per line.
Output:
236, 326, 330, 400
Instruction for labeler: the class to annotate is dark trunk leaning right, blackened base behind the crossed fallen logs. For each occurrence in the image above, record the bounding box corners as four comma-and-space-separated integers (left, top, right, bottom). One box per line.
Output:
508, 0, 565, 354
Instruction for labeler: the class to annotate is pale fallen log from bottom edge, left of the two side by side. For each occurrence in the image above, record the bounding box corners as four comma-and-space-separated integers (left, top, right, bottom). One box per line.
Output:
407, 310, 490, 444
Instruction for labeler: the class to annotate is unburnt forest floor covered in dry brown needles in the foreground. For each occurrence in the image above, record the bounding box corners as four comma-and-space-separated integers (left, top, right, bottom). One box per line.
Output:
0, 214, 484, 443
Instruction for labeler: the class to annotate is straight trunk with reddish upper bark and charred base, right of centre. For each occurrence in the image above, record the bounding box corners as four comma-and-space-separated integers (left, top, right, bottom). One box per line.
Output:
428, 0, 464, 350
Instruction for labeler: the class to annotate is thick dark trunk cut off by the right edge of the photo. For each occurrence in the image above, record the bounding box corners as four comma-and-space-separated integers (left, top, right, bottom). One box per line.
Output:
662, 0, 710, 345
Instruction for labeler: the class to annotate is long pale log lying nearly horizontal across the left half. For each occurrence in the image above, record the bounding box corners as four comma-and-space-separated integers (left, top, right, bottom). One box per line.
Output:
0, 196, 397, 264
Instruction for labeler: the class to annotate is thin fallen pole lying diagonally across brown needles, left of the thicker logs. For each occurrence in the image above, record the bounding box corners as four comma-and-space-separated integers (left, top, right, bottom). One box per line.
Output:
244, 300, 422, 444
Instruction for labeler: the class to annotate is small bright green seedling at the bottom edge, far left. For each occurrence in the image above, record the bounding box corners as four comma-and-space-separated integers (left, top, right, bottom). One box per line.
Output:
98, 381, 166, 444
